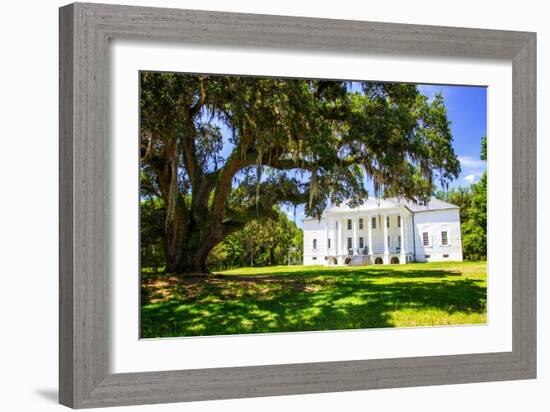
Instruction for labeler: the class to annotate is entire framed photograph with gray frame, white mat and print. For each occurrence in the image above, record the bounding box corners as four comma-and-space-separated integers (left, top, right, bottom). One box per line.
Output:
59, 3, 536, 408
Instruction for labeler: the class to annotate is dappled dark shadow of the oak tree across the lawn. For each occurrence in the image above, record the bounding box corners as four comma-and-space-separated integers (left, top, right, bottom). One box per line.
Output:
141, 270, 486, 338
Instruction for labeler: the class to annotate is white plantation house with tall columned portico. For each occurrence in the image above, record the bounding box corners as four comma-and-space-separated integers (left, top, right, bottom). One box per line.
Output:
303, 198, 462, 265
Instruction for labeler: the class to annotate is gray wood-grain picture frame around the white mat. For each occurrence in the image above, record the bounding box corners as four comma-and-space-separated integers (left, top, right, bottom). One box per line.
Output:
59, 3, 536, 408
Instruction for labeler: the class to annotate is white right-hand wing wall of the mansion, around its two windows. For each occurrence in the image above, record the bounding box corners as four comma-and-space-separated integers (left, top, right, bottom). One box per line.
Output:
414, 209, 462, 262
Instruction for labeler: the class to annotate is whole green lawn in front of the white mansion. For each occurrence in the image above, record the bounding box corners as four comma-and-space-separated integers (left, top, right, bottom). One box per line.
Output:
141, 262, 487, 338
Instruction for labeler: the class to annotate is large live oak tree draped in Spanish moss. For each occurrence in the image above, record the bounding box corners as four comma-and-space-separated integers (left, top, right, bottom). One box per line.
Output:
140, 72, 460, 273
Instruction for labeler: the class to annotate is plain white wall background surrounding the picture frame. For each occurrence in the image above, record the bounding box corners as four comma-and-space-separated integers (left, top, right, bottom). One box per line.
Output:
0, 0, 550, 412
